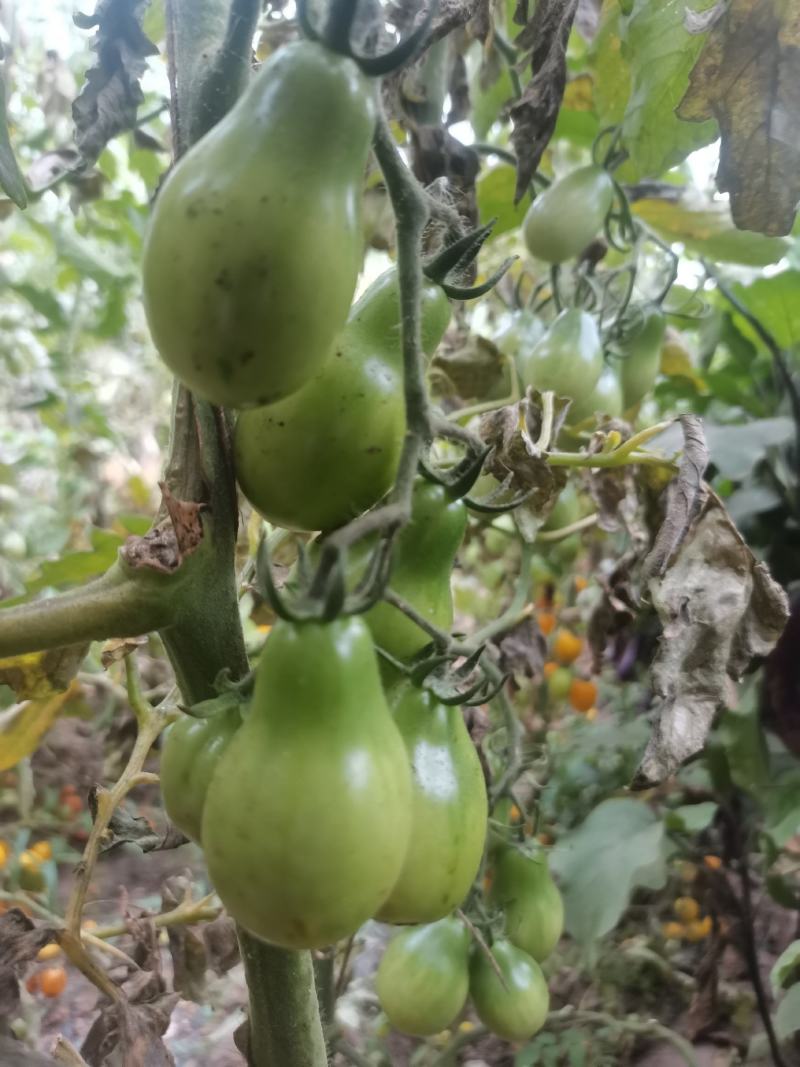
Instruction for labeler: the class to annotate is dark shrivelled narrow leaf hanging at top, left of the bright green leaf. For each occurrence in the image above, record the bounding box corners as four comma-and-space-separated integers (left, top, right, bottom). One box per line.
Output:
511, 0, 578, 204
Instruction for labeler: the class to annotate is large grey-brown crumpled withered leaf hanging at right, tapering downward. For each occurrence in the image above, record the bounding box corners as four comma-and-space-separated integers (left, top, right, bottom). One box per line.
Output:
631, 487, 788, 789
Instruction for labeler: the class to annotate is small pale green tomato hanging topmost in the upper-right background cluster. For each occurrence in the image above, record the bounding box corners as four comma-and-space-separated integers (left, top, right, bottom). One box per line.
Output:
523, 165, 614, 264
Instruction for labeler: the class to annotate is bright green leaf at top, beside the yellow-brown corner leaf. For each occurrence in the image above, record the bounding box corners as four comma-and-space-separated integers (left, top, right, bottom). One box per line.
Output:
622, 0, 717, 177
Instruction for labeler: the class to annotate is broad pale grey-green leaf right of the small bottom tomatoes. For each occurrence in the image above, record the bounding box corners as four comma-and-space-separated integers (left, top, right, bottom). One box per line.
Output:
550, 797, 668, 945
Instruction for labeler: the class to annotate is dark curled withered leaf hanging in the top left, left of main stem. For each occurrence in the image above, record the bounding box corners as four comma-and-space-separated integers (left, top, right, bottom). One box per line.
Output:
73, 0, 158, 164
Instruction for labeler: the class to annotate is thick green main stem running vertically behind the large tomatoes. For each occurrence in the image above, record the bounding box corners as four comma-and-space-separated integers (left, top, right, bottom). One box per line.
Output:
162, 0, 327, 1067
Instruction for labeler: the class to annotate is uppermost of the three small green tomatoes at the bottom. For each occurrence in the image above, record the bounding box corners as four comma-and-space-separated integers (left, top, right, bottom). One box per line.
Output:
492, 848, 564, 964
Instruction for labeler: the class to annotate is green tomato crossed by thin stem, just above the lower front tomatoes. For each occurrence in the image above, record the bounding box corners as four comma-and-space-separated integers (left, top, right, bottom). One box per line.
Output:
364, 478, 467, 659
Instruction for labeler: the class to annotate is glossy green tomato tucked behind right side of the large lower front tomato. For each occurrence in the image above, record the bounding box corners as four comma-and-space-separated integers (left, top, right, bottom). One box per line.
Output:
375, 685, 487, 923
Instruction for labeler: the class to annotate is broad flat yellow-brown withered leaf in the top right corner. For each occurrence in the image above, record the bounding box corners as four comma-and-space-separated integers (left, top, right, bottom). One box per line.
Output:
677, 0, 800, 237
